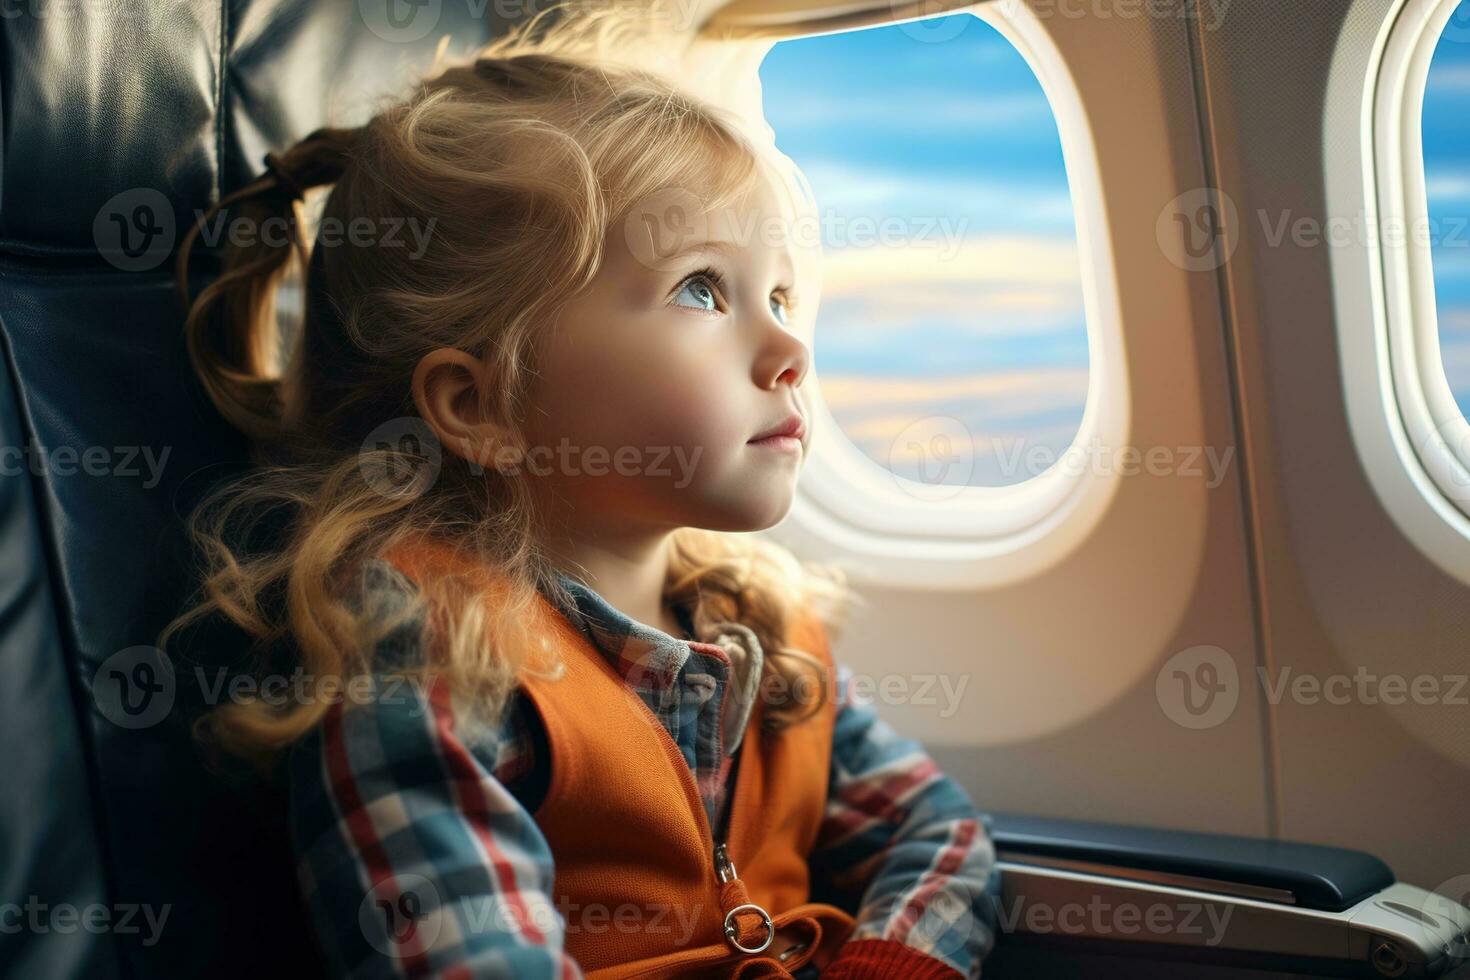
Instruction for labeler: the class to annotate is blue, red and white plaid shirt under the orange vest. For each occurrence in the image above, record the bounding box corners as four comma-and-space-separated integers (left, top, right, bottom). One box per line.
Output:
287, 561, 998, 980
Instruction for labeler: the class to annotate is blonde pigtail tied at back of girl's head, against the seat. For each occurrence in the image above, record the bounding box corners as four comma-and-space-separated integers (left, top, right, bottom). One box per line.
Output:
175, 126, 359, 442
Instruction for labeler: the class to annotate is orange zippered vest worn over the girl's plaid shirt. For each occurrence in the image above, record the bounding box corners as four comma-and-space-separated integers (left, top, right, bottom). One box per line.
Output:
387, 541, 854, 980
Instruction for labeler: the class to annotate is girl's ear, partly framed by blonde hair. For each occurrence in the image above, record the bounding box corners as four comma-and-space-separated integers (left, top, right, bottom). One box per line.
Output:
413, 347, 525, 469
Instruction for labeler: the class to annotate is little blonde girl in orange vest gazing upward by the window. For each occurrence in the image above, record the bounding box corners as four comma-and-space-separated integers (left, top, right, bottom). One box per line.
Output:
165, 7, 995, 980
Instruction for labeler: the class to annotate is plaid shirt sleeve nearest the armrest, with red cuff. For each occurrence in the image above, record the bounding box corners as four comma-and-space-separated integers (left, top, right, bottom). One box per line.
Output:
809, 664, 1000, 980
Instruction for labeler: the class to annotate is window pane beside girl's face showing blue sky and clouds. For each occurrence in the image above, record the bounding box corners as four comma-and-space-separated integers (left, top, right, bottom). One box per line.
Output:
760, 13, 1088, 486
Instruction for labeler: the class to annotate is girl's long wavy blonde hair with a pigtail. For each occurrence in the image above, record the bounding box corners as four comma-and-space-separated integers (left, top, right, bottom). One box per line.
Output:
159, 4, 856, 764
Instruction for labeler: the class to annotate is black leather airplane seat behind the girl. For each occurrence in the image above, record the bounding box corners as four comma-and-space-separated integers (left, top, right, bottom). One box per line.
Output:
0, 0, 492, 977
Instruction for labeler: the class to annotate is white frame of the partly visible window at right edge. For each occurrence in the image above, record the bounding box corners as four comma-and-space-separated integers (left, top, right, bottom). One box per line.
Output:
1340, 0, 1470, 582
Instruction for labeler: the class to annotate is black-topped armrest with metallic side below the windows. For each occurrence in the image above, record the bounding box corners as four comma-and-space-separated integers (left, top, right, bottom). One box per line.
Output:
986, 814, 1470, 977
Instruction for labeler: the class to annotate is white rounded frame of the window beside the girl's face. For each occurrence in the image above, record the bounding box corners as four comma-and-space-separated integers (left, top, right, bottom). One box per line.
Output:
784, 4, 1130, 589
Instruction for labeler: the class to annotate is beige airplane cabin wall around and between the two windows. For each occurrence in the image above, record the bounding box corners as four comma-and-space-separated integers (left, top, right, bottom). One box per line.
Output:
772, 0, 1470, 887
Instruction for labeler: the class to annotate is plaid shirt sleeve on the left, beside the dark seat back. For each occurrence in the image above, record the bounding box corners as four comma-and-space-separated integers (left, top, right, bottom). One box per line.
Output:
287, 674, 582, 980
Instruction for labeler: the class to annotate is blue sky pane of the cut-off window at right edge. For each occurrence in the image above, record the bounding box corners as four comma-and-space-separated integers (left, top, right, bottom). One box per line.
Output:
1423, 0, 1470, 416
